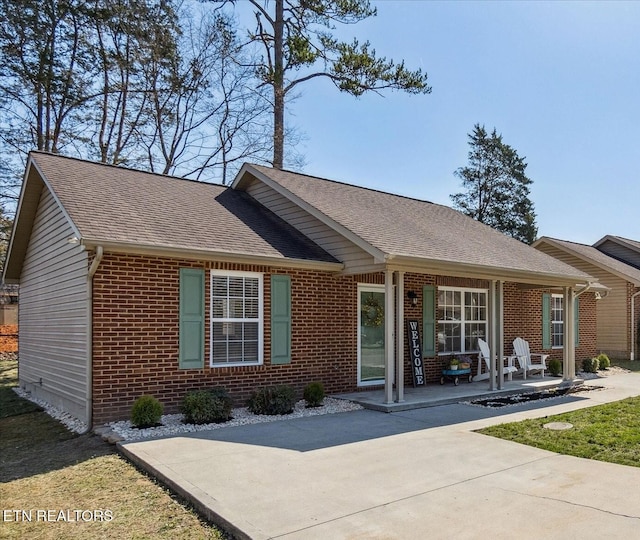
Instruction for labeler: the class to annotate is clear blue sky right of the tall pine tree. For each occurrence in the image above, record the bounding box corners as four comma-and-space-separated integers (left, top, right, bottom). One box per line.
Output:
274, 0, 640, 244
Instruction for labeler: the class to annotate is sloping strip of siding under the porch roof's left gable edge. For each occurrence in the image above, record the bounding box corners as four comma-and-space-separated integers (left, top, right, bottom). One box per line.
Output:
246, 180, 374, 272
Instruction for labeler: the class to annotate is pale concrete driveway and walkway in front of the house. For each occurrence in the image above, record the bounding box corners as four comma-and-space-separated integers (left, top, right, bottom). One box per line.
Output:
120, 373, 640, 540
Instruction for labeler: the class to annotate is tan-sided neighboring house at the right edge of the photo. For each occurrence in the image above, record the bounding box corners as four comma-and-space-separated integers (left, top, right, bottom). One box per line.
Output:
533, 236, 640, 360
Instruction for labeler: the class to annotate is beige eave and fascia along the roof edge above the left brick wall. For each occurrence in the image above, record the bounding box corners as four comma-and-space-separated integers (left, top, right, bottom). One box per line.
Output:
80, 238, 344, 272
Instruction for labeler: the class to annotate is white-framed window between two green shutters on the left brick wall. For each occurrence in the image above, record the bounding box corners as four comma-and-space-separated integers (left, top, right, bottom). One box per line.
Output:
211, 270, 263, 366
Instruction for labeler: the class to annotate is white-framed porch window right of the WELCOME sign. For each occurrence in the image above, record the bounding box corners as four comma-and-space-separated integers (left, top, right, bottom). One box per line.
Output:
437, 287, 487, 354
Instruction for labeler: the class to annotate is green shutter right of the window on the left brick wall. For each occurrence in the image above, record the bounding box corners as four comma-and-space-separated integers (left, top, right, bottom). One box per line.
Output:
271, 274, 291, 364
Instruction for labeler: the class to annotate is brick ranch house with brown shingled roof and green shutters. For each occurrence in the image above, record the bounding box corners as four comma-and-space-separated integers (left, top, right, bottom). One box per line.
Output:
3, 152, 596, 425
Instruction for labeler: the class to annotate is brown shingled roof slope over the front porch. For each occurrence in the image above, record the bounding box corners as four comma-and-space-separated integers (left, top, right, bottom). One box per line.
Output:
241, 165, 597, 283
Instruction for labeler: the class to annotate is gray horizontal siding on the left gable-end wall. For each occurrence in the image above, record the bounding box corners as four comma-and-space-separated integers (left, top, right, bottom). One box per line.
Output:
18, 188, 89, 422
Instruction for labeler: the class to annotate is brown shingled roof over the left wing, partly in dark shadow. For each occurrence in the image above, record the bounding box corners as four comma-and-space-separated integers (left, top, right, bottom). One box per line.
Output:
3, 152, 340, 278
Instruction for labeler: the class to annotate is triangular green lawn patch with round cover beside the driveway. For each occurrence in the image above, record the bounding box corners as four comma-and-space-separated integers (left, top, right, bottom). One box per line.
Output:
478, 397, 640, 467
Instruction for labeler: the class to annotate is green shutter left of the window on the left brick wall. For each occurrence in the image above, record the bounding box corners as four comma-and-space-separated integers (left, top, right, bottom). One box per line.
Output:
178, 268, 204, 369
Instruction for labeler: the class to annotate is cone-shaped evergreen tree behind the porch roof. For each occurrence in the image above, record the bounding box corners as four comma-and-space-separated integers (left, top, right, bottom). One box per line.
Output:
451, 124, 538, 244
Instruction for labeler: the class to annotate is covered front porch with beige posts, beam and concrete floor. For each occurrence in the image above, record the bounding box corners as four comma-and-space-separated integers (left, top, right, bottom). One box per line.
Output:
376, 265, 592, 411
